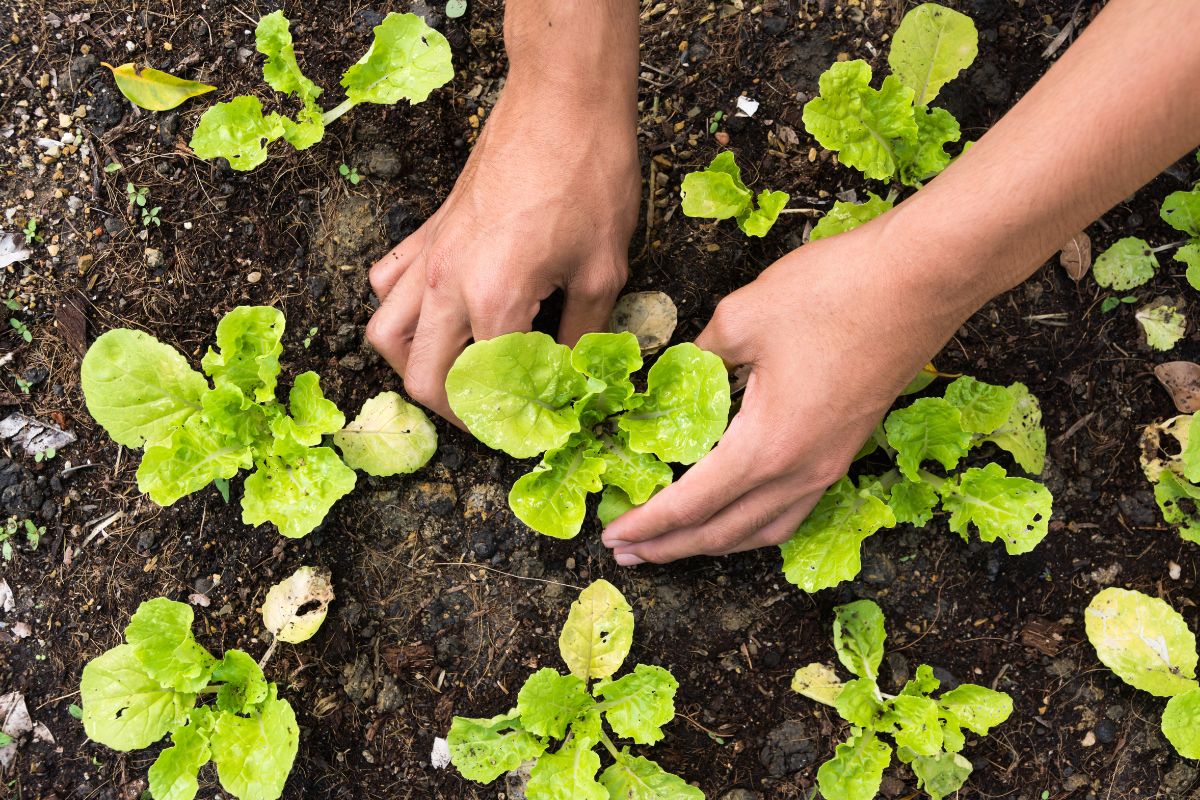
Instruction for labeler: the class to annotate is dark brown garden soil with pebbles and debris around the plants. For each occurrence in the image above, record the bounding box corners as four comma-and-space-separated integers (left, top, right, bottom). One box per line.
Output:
0, 0, 1200, 800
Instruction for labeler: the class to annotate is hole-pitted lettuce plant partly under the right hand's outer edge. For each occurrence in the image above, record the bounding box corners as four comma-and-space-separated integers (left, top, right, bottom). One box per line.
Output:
780, 377, 1054, 591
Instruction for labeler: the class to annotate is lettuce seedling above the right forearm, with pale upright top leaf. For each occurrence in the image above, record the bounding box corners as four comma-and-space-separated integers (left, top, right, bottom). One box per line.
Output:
804, 2, 979, 187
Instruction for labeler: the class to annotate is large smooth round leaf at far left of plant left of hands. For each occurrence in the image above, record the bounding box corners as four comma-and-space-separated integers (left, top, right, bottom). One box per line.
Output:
79, 329, 209, 447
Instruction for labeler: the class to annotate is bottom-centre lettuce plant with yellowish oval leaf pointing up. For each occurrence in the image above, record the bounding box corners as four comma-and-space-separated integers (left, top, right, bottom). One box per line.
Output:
446, 581, 704, 800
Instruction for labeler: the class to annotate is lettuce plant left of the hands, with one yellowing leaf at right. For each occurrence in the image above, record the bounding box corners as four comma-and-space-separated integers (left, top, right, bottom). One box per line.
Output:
82, 306, 437, 537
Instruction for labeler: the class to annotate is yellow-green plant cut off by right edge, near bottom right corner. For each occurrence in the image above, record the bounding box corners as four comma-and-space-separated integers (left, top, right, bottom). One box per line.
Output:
1084, 588, 1200, 759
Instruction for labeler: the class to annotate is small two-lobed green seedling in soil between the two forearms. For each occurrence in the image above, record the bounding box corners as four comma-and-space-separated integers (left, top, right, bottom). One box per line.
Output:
679, 151, 787, 236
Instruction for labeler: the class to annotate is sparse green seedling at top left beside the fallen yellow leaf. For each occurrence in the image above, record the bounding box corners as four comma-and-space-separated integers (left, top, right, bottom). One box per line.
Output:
191, 11, 454, 170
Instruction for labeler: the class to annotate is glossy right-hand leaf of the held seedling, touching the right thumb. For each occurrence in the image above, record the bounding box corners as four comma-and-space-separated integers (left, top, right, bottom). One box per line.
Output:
617, 342, 730, 464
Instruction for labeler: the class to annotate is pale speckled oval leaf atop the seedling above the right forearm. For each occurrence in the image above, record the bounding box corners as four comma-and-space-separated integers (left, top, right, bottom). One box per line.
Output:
888, 2, 979, 106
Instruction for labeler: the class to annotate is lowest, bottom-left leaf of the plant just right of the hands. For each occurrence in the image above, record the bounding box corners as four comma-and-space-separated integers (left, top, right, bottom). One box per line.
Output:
779, 477, 896, 591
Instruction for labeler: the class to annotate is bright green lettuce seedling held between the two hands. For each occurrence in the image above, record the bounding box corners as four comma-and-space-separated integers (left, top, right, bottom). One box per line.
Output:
446, 332, 730, 539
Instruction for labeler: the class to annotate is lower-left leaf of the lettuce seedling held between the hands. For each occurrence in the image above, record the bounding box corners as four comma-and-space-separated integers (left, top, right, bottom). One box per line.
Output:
509, 439, 605, 539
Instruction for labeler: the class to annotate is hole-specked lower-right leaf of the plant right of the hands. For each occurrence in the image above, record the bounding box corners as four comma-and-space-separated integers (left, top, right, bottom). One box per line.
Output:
942, 464, 1054, 555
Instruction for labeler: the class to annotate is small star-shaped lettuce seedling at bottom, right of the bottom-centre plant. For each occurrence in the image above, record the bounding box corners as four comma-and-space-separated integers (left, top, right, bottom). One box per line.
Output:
792, 600, 1013, 800
